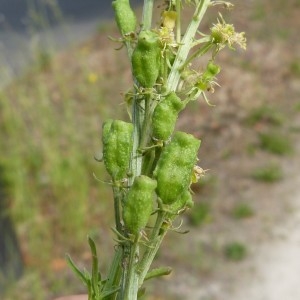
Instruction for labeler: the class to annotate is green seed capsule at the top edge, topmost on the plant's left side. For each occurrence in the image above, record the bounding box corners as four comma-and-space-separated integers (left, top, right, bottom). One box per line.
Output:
112, 0, 137, 35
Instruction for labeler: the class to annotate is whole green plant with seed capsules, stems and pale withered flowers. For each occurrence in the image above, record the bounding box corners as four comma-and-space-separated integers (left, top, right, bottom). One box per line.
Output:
68, 0, 246, 300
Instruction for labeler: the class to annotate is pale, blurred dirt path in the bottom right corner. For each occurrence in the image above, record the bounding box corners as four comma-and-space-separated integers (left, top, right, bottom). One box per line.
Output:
231, 140, 300, 300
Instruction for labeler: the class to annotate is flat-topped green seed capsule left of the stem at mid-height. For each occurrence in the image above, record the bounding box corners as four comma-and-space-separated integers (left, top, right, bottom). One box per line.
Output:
102, 120, 133, 181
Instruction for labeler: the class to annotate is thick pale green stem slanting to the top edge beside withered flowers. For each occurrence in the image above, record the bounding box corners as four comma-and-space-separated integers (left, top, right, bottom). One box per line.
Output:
166, 0, 211, 91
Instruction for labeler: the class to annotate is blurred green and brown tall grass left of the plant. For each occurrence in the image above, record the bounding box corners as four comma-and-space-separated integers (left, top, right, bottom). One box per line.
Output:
0, 26, 127, 299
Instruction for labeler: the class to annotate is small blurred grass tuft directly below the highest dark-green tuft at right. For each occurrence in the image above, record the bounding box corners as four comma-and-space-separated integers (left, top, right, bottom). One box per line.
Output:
251, 163, 283, 183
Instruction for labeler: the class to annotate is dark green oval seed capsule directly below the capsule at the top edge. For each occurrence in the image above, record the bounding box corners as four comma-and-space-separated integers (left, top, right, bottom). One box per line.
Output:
132, 30, 161, 88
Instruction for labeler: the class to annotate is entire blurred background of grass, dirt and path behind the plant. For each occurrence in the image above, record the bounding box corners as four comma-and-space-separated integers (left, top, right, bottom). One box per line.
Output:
0, 0, 300, 300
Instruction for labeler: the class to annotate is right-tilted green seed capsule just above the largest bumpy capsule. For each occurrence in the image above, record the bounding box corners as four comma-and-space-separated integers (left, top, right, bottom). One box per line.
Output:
152, 92, 185, 141
